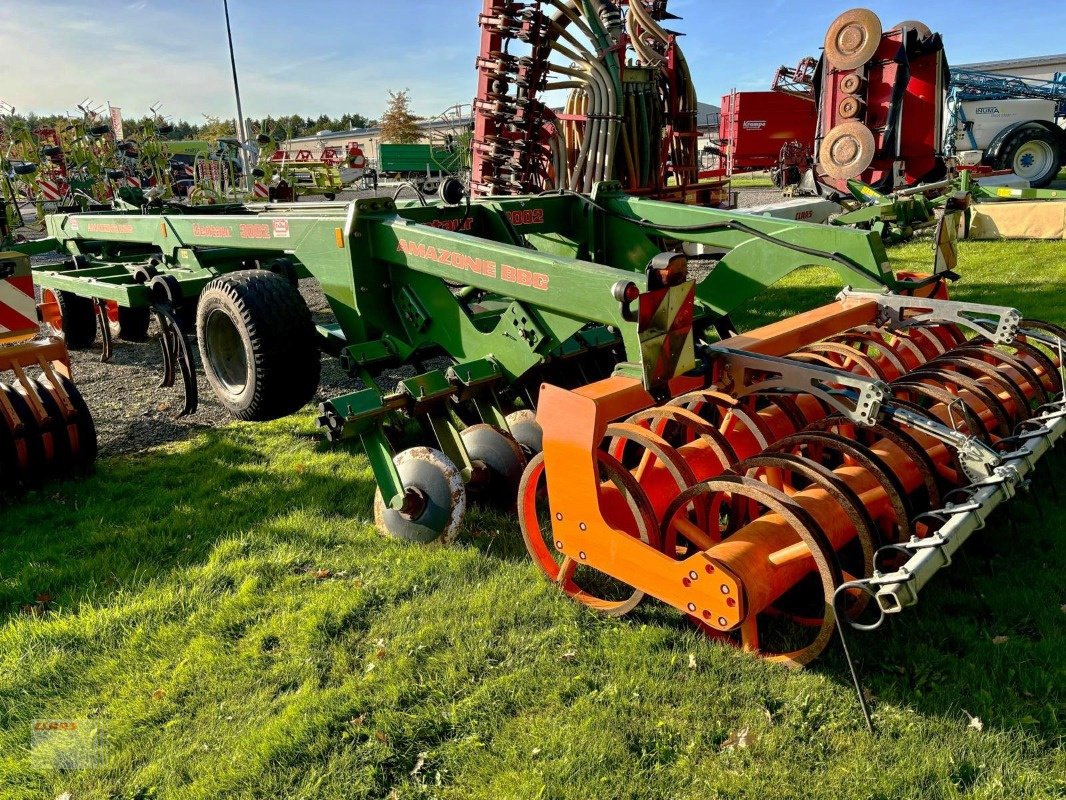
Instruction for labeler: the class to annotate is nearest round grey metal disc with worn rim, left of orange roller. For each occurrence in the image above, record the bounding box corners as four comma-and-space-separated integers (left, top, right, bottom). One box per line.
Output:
374, 447, 466, 544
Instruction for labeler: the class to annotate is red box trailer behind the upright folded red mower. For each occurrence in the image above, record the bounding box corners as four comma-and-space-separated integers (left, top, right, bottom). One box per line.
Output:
718, 91, 818, 175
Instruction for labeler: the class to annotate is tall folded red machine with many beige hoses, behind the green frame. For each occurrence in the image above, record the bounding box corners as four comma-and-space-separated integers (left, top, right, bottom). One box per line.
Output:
471, 0, 728, 205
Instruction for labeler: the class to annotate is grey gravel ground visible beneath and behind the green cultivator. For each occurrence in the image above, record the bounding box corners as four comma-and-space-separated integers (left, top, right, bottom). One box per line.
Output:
12, 182, 780, 457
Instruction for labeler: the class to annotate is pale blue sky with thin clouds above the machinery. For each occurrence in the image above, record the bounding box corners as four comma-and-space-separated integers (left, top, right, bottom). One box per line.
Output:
0, 0, 1066, 119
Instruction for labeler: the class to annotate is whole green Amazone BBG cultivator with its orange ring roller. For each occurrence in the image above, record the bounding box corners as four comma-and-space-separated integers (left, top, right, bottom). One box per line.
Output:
27, 173, 1066, 699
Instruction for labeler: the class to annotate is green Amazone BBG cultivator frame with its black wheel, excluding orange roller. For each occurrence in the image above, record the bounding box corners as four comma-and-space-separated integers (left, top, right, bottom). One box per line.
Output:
35, 183, 895, 538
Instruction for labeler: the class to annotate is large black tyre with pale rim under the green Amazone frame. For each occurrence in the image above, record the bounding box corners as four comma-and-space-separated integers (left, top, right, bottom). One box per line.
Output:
196, 270, 322, 421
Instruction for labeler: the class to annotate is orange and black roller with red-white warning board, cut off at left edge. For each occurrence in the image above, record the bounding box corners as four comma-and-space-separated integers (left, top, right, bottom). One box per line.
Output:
0, 252, 96, 495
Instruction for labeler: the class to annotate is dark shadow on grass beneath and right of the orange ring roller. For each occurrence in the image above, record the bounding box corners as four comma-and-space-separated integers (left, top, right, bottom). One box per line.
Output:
462, 439, 1066, 746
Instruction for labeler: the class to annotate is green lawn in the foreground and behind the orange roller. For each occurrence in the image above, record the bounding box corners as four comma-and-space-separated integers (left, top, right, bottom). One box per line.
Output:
0, 243, 1066, 800
